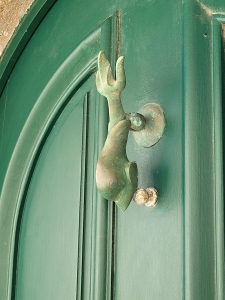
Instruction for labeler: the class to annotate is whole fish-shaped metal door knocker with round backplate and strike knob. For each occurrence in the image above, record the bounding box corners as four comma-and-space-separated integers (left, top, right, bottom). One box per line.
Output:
96, 52, 165, 211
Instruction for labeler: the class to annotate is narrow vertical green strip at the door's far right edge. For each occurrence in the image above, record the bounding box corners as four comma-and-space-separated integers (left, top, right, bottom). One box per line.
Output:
212, 19, 225, 300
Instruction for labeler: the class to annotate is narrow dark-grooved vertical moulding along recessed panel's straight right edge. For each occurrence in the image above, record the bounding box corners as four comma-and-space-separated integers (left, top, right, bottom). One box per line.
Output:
77, 93, 95, 300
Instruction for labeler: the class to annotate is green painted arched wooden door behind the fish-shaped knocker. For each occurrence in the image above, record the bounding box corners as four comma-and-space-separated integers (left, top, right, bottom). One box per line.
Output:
0, 0, 225, 300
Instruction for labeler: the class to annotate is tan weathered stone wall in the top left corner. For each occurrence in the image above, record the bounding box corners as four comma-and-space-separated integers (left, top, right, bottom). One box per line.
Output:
0, 0, 35, 57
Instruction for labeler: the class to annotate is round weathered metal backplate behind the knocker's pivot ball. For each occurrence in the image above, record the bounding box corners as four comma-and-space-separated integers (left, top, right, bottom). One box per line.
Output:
133, 103, 166, 148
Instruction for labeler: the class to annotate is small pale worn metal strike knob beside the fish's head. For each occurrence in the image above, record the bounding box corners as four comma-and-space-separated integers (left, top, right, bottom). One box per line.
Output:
133, 187, 158, 207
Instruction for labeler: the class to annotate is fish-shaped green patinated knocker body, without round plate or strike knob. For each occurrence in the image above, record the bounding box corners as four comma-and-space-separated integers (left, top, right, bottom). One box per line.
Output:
96, 52, 138, 211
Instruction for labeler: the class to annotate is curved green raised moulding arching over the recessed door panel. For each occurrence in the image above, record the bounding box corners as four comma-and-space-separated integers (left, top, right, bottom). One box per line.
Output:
0, 28, 101, 300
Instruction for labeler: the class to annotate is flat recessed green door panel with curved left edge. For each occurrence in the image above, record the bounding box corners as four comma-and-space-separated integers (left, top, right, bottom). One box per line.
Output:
16, 91, 84, 300
